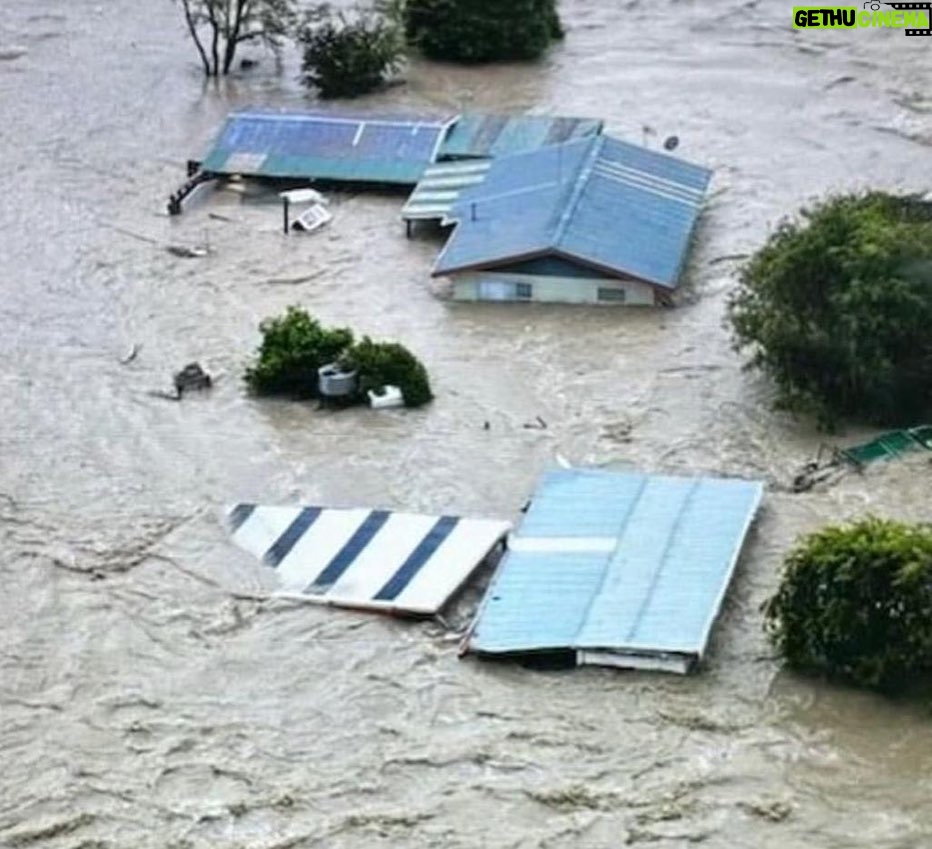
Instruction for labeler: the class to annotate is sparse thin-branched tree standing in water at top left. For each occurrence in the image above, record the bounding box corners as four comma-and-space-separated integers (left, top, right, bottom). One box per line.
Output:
177, 0, 295, 77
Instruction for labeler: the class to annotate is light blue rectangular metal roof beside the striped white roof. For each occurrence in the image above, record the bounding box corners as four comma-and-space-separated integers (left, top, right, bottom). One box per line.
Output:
466, 469, 763, 672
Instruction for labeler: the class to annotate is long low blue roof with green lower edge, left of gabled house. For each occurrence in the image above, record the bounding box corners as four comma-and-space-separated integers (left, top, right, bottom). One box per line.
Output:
201, 112, 448, 185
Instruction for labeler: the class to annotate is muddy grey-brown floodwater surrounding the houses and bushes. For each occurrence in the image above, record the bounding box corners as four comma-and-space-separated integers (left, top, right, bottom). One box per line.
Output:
0, 0, 932, 849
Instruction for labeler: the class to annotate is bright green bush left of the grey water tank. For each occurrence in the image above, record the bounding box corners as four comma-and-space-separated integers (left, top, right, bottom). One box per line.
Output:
245, 306, 353, 398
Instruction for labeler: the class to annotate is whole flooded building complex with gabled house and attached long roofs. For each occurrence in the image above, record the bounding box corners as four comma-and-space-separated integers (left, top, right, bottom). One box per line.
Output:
169, 110, 711, 306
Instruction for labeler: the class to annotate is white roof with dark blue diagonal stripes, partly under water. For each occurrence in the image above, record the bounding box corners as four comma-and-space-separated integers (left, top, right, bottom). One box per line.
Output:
228, 504, 510, 616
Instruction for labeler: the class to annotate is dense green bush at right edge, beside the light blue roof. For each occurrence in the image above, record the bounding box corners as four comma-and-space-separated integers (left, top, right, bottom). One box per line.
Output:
765, 518, 932, 692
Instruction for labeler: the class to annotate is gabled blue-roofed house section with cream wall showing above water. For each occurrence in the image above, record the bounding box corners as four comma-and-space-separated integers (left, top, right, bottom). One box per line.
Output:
433, 135, 711, 306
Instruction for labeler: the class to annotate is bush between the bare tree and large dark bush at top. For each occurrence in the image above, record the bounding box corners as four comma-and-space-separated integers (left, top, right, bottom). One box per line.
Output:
297, 5, 404, 98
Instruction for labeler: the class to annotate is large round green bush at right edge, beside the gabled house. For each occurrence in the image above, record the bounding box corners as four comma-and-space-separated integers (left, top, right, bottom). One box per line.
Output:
729, 192, 932, 427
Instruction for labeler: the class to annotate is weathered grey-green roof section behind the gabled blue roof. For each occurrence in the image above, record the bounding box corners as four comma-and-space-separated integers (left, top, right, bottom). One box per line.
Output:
440, 114, 602, 159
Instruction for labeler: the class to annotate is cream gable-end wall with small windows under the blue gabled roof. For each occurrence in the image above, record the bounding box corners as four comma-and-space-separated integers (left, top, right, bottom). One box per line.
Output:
450, 271, 655, 306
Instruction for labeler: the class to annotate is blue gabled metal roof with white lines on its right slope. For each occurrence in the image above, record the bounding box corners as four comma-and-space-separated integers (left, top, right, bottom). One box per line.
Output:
434, 136, 711, 289
